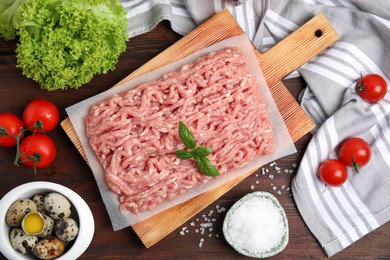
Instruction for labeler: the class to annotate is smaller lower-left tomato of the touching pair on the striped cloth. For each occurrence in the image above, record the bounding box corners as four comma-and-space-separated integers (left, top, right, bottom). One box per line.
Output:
317, 160, 348, 187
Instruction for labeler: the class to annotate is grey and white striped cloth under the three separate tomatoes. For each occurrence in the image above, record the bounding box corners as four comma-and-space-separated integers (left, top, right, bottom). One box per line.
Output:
123, 0, 390, 256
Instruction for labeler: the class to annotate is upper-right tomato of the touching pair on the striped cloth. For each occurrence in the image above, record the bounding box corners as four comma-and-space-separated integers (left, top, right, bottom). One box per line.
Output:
339, 137, 371, 172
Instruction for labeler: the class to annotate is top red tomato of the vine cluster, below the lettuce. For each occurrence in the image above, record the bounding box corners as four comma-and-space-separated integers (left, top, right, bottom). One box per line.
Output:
23, 99, 60, 133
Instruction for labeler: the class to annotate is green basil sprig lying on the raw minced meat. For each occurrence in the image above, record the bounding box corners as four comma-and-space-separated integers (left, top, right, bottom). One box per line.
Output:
176, 121, 220, 177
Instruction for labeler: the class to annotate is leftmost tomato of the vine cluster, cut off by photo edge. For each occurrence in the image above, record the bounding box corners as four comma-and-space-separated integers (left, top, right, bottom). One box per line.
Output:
0, 112, 23, 147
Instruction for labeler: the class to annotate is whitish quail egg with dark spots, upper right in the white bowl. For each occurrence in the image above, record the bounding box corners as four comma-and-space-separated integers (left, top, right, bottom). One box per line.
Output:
45, 192, 72, 220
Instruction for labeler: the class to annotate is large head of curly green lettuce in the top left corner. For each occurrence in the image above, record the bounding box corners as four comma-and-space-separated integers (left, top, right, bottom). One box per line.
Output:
15, 0, 128, 90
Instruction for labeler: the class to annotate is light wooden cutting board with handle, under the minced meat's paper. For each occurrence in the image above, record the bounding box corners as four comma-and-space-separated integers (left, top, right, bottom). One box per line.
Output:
61, 9, 338, 247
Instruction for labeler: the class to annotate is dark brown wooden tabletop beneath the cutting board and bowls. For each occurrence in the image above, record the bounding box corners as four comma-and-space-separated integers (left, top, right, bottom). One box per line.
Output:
0, 19, 390, 259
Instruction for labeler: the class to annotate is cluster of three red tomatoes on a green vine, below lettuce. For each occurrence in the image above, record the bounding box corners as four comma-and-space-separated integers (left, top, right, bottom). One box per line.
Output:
0, 99, 60, 173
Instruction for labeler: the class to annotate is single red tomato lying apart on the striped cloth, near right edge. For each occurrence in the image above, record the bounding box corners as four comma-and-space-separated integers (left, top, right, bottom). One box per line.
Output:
356, 74, 387, 103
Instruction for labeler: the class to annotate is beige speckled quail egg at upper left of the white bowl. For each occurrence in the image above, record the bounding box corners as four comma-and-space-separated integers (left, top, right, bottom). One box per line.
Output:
5, 199, 37, 227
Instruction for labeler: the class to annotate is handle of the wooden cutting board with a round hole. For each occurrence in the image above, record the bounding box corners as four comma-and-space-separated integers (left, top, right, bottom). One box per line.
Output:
257, 13, 339, 85
